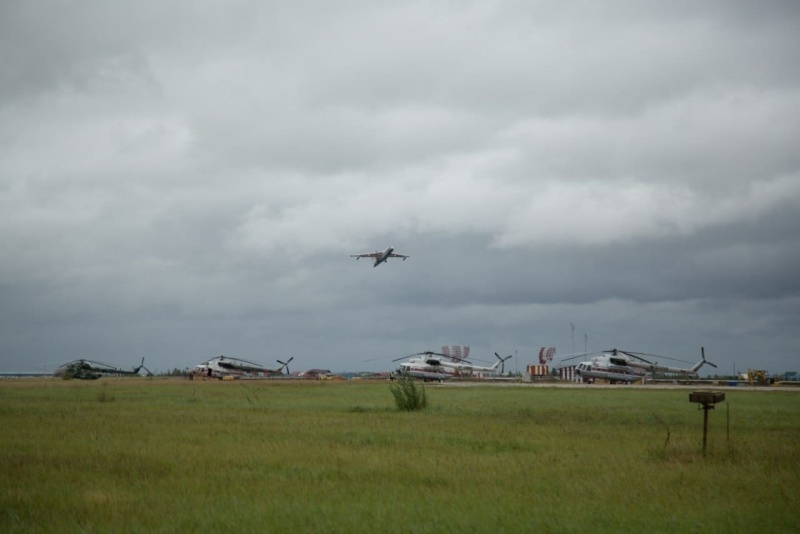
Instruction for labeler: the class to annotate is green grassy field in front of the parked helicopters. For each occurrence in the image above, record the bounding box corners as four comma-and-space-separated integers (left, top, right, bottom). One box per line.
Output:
0, 379, 800, 533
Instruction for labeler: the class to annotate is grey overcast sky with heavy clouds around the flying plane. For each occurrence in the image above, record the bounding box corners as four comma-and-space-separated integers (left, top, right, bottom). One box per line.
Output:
0, 0, 800, 374
